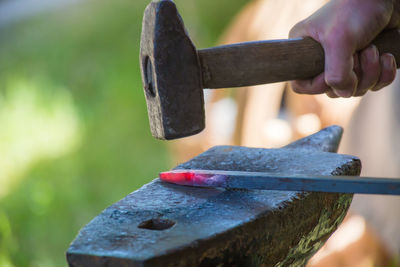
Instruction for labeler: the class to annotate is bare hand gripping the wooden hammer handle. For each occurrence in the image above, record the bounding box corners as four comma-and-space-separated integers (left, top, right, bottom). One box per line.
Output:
289, 0, 400, 97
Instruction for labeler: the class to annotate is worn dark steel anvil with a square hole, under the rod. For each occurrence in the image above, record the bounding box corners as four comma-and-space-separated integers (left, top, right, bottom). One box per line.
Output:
67, 127, 361, 266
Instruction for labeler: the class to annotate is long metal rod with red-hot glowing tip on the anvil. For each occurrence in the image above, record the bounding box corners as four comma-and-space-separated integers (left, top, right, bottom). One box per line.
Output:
160, 170, 400, 195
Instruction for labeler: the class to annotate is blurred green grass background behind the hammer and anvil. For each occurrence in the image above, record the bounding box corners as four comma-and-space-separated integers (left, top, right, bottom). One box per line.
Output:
0, 0, 246, 266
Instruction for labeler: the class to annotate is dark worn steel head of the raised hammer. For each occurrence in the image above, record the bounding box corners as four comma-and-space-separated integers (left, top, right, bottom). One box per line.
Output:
140, 0, 205, 140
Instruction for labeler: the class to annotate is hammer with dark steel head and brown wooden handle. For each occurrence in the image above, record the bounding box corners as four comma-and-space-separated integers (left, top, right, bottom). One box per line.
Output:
140, 0, 400, 140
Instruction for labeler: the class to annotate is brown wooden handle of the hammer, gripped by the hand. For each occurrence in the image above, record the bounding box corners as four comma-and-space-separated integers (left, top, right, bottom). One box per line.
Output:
198, 29, 400, 88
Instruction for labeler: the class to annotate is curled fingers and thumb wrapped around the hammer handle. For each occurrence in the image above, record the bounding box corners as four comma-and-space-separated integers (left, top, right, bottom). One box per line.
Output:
289, 21, 396, 98
